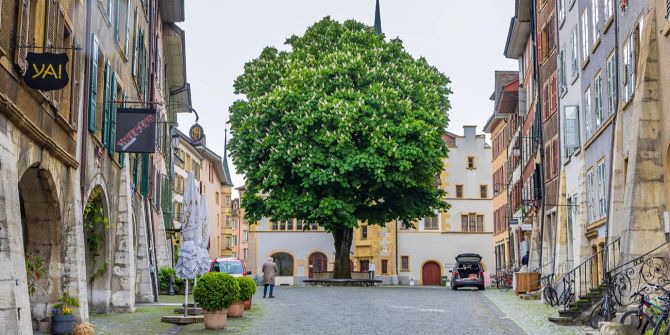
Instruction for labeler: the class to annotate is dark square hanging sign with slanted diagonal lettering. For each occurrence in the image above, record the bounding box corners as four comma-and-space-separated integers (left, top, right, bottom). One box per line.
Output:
116, 108, 156, 153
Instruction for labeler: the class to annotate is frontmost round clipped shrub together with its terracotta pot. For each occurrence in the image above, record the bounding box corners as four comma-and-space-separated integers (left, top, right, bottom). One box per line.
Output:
193, 272, 240, 329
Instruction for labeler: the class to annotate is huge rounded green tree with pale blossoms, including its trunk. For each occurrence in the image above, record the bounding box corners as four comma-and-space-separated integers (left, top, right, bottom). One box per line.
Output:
229, 17, 451, 278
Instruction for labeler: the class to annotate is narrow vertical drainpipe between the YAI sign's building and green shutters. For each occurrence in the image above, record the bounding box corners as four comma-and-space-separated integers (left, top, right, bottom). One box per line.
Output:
79, 1, 93, 201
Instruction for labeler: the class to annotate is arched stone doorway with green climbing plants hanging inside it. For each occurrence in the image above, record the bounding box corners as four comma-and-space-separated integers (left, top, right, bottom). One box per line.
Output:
83, 186, 111, 313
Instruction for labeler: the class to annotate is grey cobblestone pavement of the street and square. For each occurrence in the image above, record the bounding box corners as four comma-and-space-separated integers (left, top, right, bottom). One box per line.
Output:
91, 287, 583, 335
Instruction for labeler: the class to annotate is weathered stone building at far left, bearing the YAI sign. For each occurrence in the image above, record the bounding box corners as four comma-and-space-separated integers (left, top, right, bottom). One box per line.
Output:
0, 1, 88, 334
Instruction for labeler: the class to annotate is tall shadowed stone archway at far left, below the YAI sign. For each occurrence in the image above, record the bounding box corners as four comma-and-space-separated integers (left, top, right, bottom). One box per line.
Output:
19, 168, 63, 331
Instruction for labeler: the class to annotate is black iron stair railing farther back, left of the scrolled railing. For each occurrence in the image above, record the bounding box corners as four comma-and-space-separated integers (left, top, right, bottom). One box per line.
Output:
542, 238, 621, 310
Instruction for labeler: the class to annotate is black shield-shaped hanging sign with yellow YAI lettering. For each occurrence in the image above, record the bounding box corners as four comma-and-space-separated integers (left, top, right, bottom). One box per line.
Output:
23, 52, 70, 91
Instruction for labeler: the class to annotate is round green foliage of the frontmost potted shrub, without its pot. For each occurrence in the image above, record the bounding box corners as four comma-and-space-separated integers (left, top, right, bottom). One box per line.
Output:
193, 272, 240, 311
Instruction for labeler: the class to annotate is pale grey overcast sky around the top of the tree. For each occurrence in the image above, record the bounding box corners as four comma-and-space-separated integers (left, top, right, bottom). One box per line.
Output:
179, 0, 516, 187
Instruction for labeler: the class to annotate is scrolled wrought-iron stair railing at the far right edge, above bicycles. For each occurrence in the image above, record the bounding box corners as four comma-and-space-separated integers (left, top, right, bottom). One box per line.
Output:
607, 242, 670, 306
